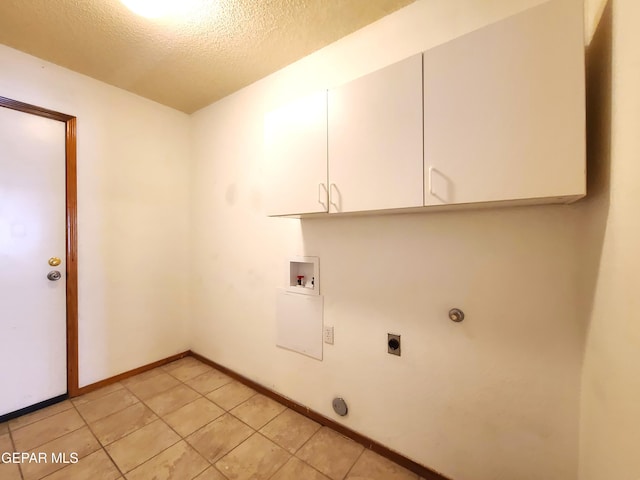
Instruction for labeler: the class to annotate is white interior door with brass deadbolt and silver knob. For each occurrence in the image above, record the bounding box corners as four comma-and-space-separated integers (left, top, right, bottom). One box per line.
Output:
0, 108, 67, 416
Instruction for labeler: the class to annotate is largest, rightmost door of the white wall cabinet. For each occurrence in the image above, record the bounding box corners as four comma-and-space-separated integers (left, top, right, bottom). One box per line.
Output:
424, 0, 585, 205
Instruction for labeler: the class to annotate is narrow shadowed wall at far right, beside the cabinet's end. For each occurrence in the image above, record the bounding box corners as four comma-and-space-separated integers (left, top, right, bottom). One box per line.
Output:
580, 0, 640, 480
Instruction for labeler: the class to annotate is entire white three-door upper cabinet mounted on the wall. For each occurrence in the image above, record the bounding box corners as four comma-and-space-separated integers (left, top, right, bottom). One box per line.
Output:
265, 0, 586, 216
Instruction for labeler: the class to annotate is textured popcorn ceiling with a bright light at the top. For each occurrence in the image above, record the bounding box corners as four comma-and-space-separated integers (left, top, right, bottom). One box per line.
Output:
0, 0, 415, 113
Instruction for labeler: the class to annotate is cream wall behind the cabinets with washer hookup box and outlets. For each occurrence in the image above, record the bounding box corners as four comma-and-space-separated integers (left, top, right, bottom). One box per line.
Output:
191, 0, 589, 480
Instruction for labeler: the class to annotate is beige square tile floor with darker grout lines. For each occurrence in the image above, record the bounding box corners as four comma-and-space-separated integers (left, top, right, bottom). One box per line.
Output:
0, 357, 419, 480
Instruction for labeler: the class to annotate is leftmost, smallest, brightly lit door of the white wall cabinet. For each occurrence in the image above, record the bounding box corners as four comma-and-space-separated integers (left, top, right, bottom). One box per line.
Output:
264, 90, 328, 216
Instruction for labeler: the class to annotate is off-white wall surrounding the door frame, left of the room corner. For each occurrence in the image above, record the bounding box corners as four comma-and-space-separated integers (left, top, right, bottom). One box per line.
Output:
0, 45, 189, 386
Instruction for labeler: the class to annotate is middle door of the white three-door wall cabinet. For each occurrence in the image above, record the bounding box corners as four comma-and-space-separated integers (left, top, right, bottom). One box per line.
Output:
329, 54, 423, 212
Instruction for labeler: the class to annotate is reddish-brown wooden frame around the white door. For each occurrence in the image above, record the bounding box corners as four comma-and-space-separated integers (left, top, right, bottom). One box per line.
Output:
0, 97, 78, 397
